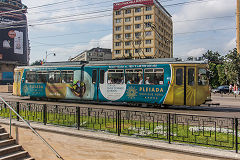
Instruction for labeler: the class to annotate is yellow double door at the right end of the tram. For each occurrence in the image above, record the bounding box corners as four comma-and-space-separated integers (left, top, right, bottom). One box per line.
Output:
173, 66, 196, 106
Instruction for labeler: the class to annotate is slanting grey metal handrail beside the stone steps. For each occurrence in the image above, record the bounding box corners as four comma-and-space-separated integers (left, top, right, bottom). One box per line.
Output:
0, 97, 64, 160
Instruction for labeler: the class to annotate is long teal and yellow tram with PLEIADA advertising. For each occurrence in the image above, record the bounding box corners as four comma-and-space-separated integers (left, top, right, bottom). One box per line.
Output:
13, 59, 210, 106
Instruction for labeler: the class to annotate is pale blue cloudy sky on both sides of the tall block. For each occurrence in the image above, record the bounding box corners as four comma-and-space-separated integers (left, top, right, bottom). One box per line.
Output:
22, 0, 236, 63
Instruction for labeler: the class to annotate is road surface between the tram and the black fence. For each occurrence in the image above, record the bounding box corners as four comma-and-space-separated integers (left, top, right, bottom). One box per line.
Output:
0, 93, 240, 118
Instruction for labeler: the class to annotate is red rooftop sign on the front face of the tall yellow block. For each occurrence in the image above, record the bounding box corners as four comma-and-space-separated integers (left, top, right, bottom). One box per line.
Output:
113, 0, 154, 10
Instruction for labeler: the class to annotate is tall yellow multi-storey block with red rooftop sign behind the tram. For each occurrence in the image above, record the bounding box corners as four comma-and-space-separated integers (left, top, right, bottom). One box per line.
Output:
112, 0, 173, 59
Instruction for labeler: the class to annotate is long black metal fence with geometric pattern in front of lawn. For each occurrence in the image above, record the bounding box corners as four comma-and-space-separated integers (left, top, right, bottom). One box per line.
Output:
0, 101, 240, 152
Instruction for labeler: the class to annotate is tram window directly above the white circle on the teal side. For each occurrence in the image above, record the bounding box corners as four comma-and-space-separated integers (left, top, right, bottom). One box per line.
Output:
108, 69, 125, 84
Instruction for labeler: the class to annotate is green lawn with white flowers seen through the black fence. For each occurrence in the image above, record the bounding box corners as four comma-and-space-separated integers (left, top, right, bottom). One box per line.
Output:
0, 107, 240, 150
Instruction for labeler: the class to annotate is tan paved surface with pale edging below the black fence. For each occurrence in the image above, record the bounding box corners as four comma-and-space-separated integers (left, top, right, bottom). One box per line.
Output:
0, 119, 240, 160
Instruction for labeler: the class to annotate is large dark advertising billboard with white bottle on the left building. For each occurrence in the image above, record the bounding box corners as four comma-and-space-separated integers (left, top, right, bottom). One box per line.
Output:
0, 6, 28, 64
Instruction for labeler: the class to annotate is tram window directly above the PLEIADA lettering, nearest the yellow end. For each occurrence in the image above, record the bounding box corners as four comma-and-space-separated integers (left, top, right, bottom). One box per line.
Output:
144, 68, 164, 85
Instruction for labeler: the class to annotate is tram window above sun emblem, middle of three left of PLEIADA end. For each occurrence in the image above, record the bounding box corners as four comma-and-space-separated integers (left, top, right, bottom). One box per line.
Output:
125, 69, 143, 84
